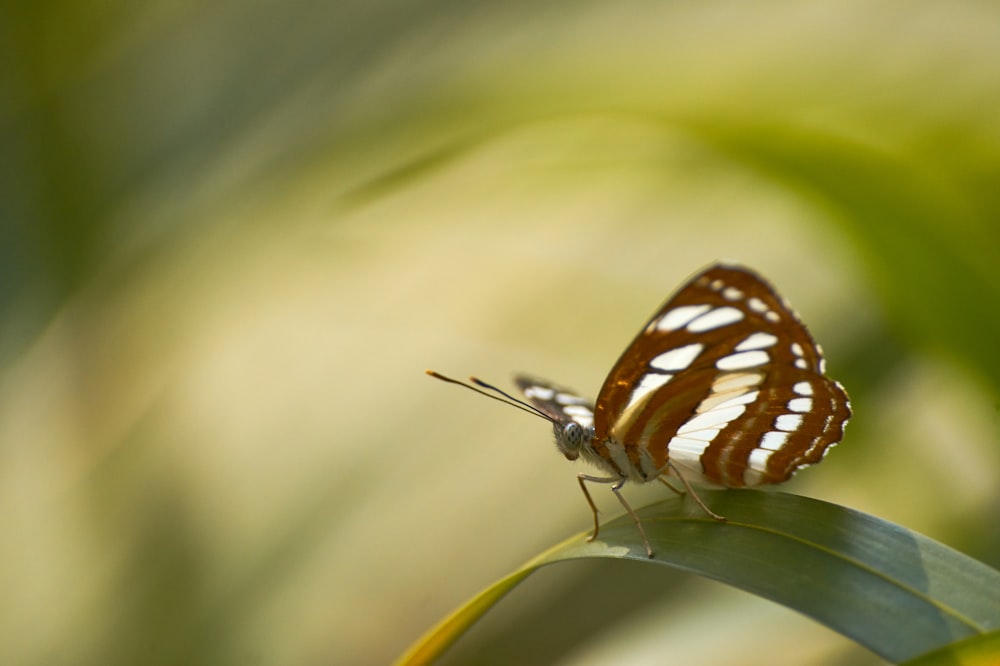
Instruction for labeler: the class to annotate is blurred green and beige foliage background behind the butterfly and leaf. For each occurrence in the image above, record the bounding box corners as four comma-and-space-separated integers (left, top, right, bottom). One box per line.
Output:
0, 0, 1000, 665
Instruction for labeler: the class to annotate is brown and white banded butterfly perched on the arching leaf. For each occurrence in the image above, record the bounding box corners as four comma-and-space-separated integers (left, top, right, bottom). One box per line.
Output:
427, 264, 851, 557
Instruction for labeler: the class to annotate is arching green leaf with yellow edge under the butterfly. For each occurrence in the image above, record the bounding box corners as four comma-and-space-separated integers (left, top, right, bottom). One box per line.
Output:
398, 490, 1000, 664
